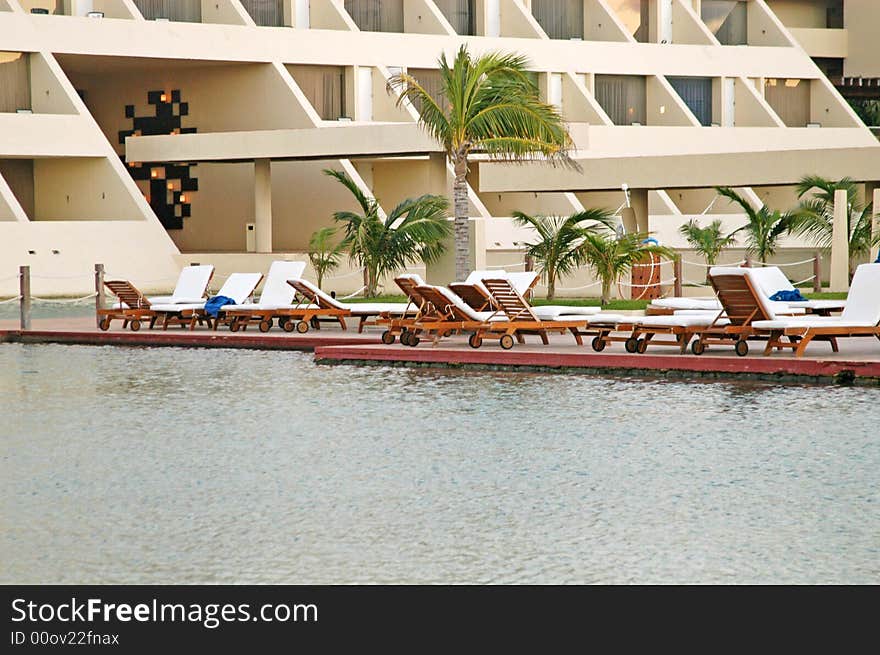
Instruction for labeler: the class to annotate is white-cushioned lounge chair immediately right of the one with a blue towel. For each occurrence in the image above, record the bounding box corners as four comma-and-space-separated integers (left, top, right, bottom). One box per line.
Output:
214, 261, 306, 332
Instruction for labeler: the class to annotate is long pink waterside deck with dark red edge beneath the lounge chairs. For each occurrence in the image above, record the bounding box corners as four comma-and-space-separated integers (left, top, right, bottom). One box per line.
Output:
0, 317, 880, 383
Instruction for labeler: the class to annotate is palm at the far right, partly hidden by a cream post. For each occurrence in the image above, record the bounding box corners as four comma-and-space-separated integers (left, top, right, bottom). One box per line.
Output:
791, 175, 880, 277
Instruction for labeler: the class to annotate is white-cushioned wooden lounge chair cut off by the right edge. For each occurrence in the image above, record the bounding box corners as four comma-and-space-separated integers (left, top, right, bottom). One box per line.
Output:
753, 264, 880, 357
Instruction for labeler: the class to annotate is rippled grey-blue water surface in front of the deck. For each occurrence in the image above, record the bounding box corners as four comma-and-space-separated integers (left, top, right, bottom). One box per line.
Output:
0, 344, 880, 583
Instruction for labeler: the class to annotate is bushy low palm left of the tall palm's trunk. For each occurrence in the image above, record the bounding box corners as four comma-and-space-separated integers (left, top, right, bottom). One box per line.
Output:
324, 169, 451, 298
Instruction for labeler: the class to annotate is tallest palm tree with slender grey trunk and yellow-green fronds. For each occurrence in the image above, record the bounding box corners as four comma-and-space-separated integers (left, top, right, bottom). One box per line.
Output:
388, 45, 573, 280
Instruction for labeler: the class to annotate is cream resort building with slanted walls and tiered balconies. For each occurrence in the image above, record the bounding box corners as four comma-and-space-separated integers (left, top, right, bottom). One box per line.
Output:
0, 0, 880, 296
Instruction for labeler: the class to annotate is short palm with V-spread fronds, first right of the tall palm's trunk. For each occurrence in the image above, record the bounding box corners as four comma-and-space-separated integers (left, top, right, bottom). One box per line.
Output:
513, 209, 612, 300
